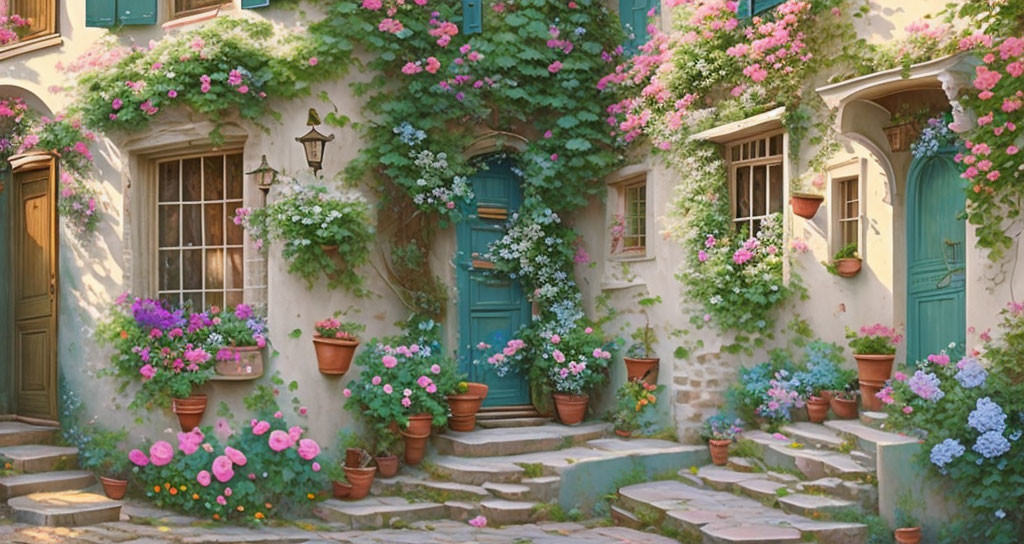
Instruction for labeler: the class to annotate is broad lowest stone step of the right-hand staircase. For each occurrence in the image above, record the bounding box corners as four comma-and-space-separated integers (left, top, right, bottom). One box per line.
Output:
617, 480, 867, 544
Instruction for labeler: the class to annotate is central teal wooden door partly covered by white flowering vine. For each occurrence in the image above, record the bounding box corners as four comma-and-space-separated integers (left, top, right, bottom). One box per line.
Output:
456, 160, 530, 406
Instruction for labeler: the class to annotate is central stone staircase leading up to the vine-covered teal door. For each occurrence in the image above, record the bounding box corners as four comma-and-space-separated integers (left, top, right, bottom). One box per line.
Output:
315, 422, 708, 529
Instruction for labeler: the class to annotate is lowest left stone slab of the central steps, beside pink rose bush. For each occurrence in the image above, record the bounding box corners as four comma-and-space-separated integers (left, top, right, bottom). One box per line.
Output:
313, 497, 449, 530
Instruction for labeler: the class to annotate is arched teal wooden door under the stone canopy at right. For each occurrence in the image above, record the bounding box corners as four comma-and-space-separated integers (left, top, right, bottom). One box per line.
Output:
906, 152, 967, 361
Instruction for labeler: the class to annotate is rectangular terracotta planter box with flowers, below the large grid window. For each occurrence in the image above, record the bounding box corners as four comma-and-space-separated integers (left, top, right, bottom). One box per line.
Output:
208, 304, 267, 380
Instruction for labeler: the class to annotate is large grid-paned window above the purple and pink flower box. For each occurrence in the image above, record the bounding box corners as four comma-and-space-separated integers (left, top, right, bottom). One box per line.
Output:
157, 153, 244, 308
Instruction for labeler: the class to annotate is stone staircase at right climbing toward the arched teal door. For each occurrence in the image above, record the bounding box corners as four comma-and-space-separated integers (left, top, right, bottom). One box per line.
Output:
611, 417, 914, 544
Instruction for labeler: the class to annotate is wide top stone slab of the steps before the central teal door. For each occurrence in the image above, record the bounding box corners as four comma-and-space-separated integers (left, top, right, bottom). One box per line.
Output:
434, 422, 611, 457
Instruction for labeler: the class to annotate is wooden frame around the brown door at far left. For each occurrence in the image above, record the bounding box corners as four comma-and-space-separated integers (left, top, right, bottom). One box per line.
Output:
7, 153, 60, 425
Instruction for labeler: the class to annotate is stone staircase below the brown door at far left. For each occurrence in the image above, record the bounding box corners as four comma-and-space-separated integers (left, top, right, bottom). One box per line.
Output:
0, 421, 121, 527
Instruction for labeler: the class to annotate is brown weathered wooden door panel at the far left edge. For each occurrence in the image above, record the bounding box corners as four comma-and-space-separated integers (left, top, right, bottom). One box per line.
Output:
9, 160, 57, 421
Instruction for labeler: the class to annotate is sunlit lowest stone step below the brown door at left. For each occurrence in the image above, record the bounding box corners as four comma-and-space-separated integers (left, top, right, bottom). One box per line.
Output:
7, 491, 121, 527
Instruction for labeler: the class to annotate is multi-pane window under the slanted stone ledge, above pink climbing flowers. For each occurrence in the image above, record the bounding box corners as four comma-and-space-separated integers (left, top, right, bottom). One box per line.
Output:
726, 134, 782, 236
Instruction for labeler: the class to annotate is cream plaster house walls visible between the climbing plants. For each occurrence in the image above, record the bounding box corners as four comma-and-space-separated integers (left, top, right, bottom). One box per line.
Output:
0, 0, 1024, 444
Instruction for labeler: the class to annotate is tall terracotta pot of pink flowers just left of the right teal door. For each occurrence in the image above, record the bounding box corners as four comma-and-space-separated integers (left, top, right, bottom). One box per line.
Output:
846, 323, 902, 412
